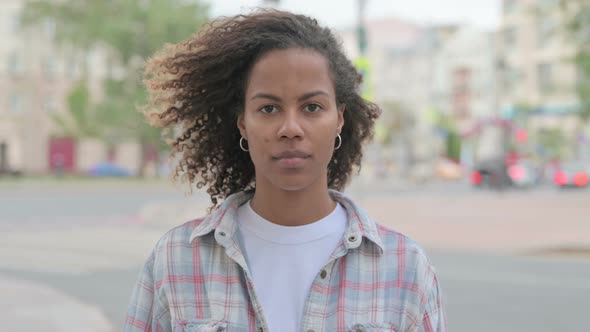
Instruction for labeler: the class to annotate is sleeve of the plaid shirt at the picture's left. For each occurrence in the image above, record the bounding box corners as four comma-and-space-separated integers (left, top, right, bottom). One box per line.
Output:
123, 252, 171, 332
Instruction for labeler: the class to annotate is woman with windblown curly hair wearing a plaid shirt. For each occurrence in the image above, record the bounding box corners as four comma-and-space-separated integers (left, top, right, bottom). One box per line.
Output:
124, 11, 445, 332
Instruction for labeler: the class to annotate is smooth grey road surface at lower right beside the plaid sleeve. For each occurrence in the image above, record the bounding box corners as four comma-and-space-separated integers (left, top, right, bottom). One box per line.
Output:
431, 251, 590, 332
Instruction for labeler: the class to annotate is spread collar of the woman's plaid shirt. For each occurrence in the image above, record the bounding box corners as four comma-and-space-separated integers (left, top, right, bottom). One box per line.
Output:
190, 190, 383, 253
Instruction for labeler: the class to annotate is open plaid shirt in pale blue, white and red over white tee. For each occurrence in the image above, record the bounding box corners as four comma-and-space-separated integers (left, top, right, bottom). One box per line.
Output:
123, 191, 446, 332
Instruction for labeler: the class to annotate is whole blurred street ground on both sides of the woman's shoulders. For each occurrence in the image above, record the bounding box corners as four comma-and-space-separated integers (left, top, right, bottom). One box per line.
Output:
0, 179, 590, 332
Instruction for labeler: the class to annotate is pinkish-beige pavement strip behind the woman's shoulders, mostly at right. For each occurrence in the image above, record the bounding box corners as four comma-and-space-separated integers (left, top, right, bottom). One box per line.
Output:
140, 184, 590, 255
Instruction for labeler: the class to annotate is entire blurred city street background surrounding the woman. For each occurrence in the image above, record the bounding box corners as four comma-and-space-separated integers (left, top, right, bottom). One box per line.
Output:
0, 0, 590, 332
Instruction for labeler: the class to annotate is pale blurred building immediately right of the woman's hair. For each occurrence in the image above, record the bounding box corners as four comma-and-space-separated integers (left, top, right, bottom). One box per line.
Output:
340, 18, 438, 176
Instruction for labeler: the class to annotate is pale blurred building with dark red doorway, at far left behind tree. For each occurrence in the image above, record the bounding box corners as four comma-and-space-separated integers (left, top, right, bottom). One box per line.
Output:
0, 0, 139, 174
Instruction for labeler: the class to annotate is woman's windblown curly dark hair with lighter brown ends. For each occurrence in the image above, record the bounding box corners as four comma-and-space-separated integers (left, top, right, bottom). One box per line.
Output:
143, 10, 381, 208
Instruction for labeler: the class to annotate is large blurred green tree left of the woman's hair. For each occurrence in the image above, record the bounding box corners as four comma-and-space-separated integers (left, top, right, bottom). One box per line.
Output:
22, 0, 208, 175
